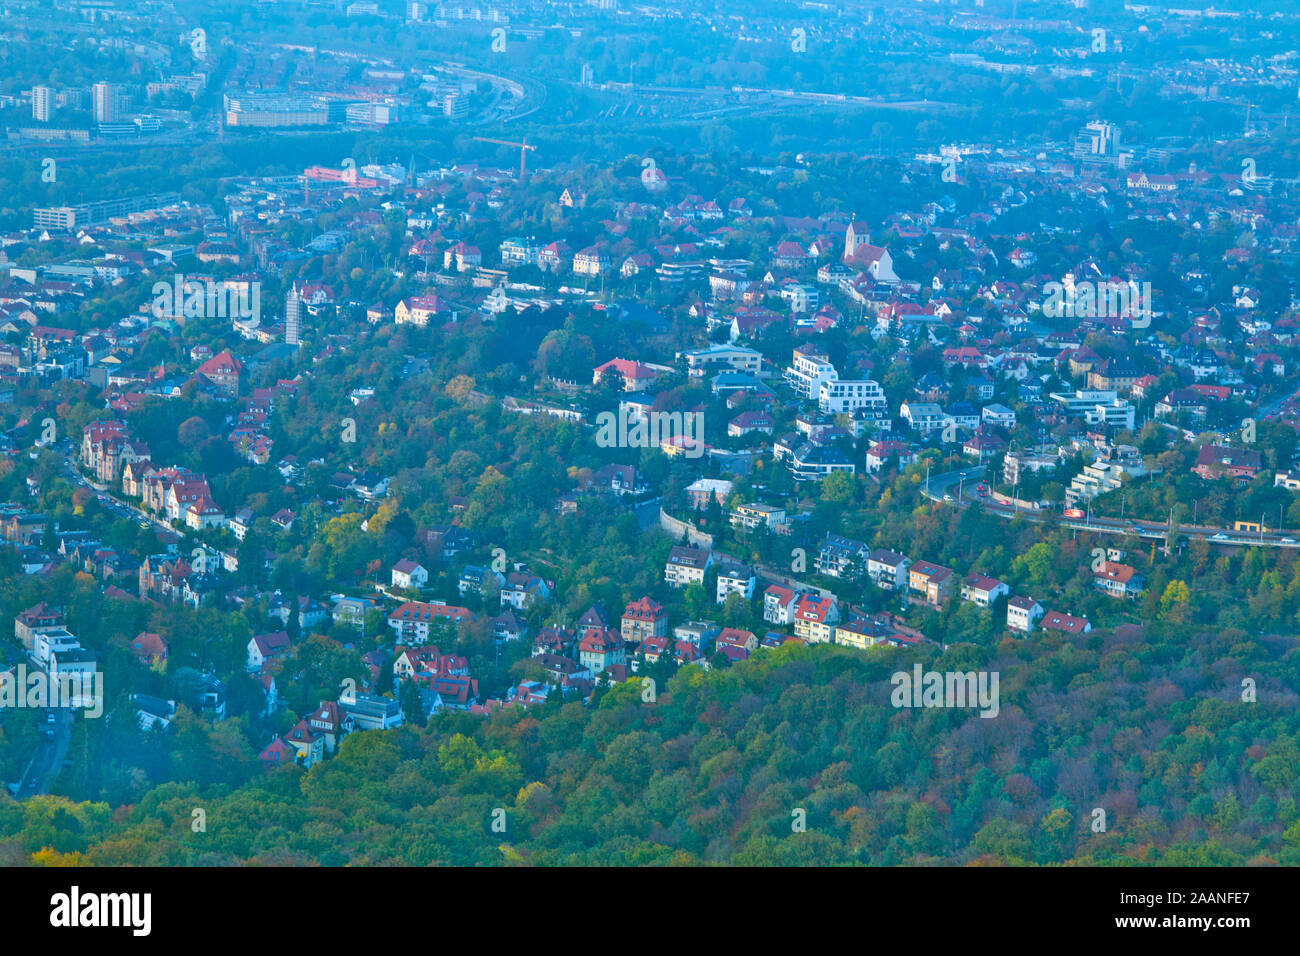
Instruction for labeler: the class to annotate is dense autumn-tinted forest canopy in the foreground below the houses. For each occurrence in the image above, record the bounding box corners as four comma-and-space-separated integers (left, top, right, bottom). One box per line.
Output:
0, 626, 1300, 865
